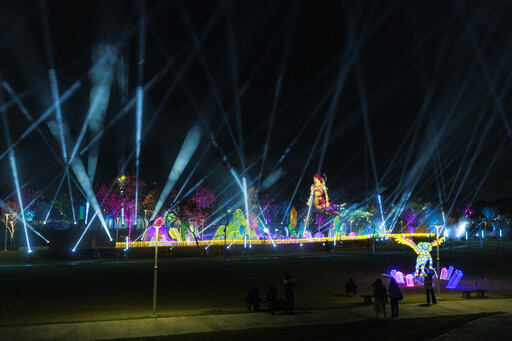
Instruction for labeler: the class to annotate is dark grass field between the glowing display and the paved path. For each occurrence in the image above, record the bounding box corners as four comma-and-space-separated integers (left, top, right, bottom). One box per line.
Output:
0, 242, 512, 326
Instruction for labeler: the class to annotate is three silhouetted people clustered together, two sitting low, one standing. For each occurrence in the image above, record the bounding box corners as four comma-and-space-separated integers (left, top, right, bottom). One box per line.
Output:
245, 272, 296, 315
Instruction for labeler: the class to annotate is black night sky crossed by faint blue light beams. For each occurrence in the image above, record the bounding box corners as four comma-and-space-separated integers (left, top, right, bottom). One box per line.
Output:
0, 0, 512, 212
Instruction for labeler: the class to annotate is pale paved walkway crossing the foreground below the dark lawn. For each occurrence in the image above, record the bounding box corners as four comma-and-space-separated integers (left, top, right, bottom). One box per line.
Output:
0, 299, 512, 341
